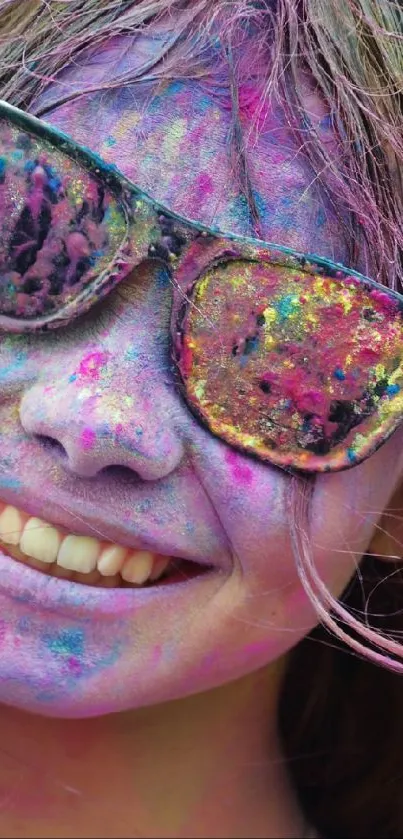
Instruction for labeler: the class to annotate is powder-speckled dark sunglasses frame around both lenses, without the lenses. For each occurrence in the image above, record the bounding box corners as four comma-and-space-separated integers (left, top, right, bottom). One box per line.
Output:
0, 100, 403, 474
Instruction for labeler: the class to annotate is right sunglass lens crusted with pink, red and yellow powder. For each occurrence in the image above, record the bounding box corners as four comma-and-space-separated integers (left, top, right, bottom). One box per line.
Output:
177, 256, 403, 471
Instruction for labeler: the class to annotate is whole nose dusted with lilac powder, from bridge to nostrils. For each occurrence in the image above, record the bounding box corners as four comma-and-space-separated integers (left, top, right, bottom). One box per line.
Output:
20, 260, 184, 481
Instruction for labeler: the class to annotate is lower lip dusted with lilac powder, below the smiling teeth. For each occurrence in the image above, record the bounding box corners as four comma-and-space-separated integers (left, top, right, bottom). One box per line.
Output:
0, 552, 221, 618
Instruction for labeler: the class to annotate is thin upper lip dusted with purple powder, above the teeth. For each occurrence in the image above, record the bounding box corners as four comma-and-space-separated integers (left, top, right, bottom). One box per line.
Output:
0, 493, 228, 570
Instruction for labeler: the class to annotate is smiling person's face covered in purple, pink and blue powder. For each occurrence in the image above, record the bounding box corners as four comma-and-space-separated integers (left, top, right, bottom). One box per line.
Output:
0, 31, 402, 716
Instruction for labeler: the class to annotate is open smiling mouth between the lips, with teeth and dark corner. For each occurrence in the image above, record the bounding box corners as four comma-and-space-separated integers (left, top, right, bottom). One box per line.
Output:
0, 503, 214, 589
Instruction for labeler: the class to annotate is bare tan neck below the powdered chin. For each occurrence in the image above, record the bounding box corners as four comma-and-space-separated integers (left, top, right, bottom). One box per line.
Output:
0, 665, 310, 839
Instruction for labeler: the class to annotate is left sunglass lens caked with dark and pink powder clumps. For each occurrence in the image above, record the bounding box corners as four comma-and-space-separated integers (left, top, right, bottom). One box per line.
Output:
0, 120, 127, 328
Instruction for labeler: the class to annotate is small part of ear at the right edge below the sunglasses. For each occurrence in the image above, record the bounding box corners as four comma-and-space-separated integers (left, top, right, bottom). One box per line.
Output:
367, 483, 403, 562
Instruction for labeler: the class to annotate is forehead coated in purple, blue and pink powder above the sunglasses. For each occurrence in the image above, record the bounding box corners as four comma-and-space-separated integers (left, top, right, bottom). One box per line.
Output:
37, 33, 348, 262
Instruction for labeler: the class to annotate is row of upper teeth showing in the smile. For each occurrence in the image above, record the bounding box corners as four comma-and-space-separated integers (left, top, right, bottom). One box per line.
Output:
0, 505, 170, 585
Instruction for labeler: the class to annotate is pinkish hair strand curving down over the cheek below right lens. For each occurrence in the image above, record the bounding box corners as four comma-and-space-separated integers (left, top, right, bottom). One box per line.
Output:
289, 477, 403, 673
